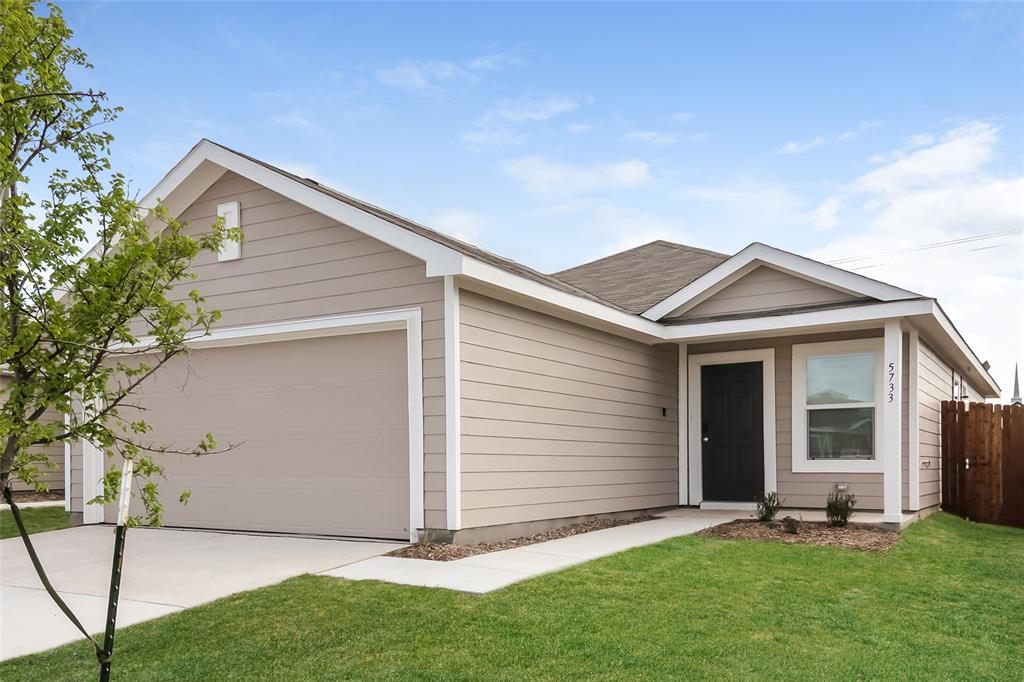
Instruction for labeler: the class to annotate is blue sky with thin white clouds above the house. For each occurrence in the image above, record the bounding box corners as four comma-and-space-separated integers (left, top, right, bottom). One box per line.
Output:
63, 3, 1024, 390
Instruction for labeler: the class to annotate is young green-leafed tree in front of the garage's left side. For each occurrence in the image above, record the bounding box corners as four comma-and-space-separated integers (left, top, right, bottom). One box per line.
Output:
0, 0, 241, 668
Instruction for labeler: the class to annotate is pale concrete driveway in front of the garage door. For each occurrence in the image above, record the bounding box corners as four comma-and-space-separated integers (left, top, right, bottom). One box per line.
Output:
0, 525, 401, 659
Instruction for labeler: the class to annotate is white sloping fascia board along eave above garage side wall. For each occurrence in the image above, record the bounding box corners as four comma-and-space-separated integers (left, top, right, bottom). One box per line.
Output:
461, 257, 666, 341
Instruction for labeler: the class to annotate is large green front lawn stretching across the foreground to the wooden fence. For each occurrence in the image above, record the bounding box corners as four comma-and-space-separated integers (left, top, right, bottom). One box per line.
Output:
0, 514, 1024, 682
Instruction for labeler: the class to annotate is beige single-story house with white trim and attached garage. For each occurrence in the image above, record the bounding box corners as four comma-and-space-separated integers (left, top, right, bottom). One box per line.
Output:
69, 140, 998, 542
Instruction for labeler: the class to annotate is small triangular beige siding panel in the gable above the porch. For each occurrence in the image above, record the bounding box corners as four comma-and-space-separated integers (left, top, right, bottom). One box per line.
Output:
668, 265, 854, 317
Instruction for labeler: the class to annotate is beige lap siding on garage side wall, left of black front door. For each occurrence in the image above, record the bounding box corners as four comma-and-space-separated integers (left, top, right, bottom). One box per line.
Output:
460, 290, 679, 527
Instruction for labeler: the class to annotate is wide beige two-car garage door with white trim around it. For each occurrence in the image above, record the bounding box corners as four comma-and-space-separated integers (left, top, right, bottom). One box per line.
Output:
105, 331, 410, 539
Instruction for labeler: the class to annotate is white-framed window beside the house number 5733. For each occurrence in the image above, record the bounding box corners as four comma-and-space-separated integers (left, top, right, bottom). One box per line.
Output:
793, 338, 884, 473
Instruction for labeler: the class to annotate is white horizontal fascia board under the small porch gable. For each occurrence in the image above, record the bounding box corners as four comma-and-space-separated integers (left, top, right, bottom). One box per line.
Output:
665, 299, 934, 341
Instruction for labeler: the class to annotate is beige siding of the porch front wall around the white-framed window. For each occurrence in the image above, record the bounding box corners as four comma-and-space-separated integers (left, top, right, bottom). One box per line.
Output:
687, 329, 909, 509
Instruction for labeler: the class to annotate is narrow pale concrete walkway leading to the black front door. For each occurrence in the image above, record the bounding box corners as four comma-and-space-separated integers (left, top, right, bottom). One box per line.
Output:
324, 509, 748, 594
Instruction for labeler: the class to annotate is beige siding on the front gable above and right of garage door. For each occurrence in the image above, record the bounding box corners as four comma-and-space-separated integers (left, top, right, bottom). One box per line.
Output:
73, 172, 446, 528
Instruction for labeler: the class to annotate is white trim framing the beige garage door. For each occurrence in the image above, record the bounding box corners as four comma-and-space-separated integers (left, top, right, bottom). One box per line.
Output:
83, 308, 423, 542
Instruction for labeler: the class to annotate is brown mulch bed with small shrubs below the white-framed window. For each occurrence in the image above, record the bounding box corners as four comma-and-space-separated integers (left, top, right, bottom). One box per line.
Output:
696, 520, 899, 551
